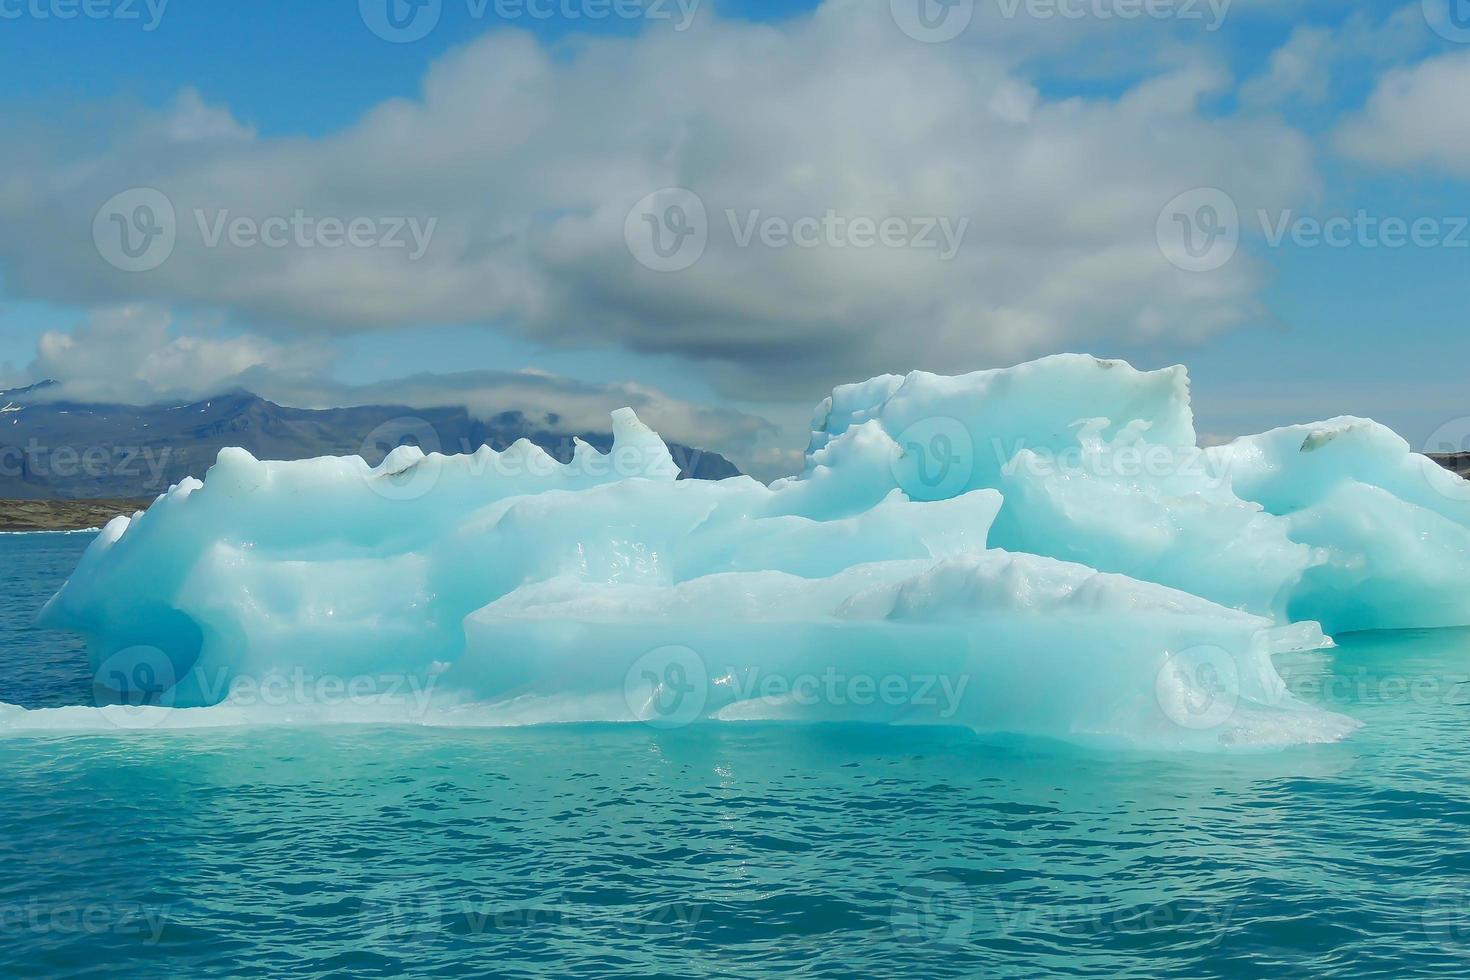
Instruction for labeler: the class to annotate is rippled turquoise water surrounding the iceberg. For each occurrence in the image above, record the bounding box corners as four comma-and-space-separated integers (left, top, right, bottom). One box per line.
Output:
0, 535, 1470, 977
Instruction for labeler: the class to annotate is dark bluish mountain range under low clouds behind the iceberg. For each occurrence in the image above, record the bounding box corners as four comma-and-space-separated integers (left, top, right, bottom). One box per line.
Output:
0, 382, 739, 500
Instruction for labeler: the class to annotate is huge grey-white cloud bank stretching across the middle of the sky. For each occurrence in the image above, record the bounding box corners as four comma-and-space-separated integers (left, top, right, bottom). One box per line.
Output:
0, 3, 1314, 401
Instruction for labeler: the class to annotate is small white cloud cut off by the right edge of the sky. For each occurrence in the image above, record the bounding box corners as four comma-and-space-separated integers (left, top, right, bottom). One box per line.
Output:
1338, 51, 1470, 178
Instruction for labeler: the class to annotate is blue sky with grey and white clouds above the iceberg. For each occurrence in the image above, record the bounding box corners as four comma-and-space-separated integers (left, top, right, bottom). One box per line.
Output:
0, 0, 1470, 478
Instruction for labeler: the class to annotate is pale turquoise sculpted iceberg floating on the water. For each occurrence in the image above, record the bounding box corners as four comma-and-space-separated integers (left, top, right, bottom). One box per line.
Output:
14, 354, 1470, 751
